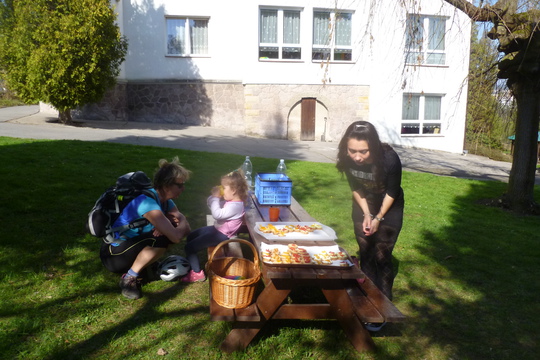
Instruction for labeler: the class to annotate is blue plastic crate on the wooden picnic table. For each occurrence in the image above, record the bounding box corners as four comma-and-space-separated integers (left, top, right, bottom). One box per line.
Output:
255, 173, 292, 206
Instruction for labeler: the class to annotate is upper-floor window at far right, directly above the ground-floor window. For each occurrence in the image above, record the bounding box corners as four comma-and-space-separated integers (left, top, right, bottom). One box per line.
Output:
405, 14, 446, 65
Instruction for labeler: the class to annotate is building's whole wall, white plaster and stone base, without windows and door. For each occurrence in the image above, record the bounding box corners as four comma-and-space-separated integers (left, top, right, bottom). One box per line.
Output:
79, 0, 470, 152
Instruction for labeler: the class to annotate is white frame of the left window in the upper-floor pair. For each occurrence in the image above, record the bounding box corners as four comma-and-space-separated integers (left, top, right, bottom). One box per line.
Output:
258, 7, 303, 61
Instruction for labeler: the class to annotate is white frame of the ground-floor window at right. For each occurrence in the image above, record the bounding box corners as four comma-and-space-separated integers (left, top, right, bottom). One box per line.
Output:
401, 93, 444, 136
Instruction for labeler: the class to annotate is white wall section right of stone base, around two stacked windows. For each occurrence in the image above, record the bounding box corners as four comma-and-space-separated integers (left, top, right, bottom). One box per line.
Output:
370, 1, 470, 153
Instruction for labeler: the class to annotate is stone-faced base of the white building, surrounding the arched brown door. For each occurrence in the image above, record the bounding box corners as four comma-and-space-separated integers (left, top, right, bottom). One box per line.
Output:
74, 82, 369, 141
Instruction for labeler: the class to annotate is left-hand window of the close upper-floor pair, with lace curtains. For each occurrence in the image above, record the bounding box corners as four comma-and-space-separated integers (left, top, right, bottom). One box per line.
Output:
259, 9, 302, 60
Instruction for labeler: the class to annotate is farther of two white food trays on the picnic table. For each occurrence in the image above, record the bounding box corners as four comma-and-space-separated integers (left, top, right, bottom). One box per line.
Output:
254, 222, 336, 241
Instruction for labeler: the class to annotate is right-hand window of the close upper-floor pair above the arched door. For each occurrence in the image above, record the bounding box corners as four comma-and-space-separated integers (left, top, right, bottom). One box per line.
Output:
312, 11, 352, 61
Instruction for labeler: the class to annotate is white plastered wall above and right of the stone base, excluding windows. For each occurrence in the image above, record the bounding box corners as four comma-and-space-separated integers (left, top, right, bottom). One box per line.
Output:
117, 0, 470, 153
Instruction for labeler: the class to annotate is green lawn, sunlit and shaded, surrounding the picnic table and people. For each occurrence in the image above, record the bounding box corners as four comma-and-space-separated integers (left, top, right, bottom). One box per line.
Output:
0, 137, 540, 359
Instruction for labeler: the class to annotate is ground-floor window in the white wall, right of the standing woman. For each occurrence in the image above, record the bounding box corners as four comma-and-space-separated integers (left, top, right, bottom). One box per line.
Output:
401, 94, 442, 135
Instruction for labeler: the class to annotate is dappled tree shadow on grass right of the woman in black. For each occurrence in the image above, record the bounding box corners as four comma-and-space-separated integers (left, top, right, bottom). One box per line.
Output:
394, 180, 540, 359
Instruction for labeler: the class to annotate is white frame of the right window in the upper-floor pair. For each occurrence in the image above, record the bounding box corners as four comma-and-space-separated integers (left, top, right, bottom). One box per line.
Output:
311, 9, 354, 63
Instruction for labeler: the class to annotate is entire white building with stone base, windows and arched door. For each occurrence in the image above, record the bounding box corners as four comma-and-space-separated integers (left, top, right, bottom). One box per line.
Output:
85, 0, 471, 153
